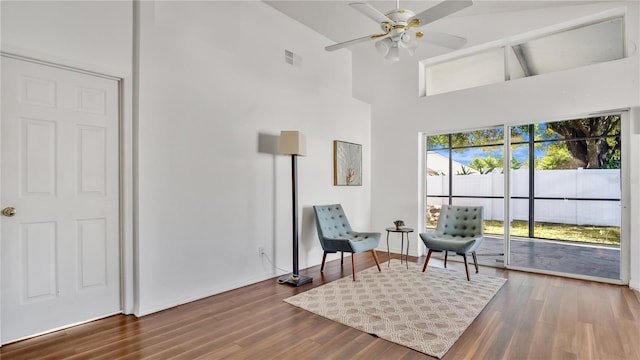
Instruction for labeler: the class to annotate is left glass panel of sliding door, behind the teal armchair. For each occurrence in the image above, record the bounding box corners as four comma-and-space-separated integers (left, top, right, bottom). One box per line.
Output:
425, 127, 504, 266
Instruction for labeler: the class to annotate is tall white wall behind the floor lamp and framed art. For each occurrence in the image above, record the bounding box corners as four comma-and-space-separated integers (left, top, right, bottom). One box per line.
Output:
138, 1, 371, 314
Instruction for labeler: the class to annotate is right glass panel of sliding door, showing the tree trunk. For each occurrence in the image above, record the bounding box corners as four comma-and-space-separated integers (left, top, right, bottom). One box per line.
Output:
509, 115, 622, 279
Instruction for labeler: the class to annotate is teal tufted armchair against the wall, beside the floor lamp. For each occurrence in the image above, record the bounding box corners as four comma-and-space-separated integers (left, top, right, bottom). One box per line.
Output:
313, 204, 381, 281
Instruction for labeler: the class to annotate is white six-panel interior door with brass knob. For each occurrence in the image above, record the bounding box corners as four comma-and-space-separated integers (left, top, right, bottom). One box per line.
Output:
0, 56, 121, 344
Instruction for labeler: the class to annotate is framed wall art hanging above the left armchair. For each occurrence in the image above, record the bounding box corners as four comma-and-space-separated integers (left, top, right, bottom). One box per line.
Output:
333, 140, 362, 186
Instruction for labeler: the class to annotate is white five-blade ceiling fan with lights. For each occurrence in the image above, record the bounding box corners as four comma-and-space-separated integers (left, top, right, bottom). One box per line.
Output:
324, 0, 473, 62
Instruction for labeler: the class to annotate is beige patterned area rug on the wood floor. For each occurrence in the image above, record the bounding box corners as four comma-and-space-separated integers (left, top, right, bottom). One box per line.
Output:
284, 260, 507, 358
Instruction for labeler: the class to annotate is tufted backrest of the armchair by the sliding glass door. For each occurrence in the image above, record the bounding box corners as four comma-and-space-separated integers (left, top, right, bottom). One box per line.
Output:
436, 205, 484, 238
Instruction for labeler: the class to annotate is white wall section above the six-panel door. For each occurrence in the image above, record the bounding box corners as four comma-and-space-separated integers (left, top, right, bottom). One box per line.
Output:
1, 0, 133, 77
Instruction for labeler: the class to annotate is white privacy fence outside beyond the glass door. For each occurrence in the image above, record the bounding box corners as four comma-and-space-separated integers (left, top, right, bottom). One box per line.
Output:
427, 169, 621, 226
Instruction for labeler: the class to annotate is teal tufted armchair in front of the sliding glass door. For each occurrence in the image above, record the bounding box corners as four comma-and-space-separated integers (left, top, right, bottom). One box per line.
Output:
420, 205, 484, 280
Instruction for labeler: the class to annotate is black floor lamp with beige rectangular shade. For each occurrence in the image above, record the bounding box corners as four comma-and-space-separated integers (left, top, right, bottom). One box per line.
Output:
278, 131, 313, 286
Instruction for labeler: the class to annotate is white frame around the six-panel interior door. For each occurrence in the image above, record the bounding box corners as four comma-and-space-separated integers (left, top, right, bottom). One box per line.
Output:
0, 50, 137, 347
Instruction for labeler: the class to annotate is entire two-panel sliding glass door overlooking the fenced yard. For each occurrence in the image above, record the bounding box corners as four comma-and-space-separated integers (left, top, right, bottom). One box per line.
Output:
425, 114, 623, 280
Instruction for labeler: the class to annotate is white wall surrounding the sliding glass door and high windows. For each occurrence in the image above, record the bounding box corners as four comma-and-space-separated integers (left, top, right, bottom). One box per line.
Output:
354, 2, 640, 288
